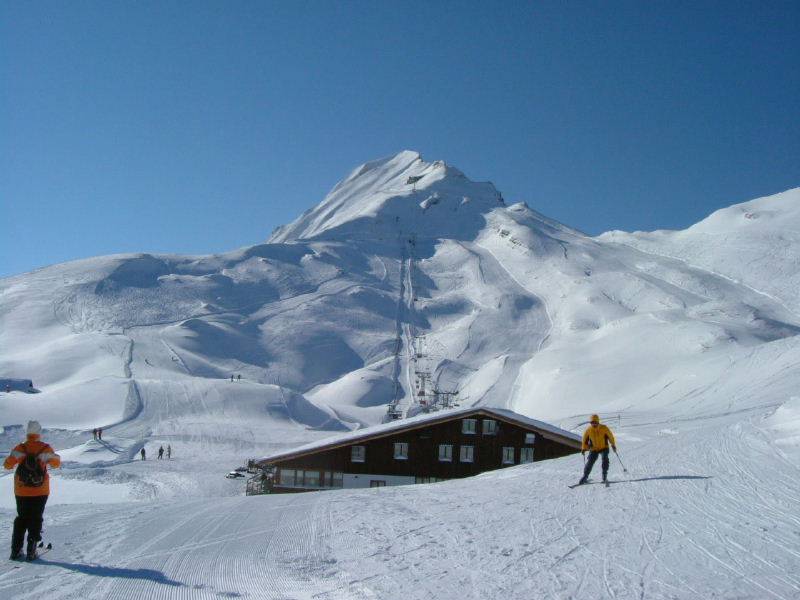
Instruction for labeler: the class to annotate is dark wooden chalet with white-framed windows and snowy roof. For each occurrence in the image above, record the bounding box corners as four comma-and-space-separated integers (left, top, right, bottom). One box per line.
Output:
248, 407, 581, 494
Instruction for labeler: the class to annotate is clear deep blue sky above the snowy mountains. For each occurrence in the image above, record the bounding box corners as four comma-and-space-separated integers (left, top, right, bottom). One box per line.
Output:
0, 0, 800, 276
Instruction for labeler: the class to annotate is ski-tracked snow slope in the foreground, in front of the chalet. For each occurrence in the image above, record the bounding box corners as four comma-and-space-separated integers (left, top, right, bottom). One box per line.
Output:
0, 354, 800, 600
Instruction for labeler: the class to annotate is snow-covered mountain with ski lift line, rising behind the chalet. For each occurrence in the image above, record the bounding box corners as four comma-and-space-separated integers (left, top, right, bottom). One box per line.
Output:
0, 151, 800, 454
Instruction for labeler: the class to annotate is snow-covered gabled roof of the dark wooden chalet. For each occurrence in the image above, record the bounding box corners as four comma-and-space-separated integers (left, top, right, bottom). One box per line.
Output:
257, 406, 581, 464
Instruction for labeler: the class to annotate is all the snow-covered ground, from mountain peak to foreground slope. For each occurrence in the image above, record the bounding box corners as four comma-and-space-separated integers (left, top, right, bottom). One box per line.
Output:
0, 152, 800, 600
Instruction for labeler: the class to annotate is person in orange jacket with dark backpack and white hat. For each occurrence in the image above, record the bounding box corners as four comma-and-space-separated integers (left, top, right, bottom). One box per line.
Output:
3, 421, 61, 560
